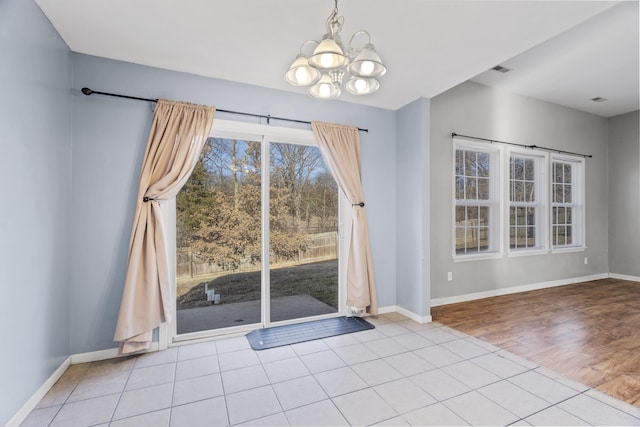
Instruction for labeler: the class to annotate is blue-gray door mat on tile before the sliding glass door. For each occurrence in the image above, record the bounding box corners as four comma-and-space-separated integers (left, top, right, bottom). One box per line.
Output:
247, 317, 375, 350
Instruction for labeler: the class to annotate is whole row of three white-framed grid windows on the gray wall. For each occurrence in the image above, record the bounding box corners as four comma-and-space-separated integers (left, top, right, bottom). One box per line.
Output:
453, 138, 585, 261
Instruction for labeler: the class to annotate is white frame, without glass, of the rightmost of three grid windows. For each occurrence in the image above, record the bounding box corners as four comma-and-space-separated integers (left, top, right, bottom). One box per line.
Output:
548, 154, 586, 253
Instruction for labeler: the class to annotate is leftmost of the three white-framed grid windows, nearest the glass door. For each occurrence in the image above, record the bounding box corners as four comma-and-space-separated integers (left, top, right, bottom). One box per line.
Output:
455, 144, 499, 255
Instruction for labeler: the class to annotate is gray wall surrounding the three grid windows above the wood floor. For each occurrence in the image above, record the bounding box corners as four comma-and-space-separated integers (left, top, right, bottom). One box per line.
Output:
428, 82, 609, 298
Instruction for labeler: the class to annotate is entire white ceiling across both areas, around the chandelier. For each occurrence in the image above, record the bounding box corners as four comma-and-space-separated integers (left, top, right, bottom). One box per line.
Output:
36, 0, 639, 116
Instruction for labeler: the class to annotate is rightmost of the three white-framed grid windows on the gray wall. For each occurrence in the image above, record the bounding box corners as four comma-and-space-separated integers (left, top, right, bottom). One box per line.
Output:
551, 157, 584, 249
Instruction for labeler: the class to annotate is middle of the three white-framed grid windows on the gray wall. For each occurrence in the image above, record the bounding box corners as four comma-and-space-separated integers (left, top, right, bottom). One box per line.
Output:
509, 152, 546, 251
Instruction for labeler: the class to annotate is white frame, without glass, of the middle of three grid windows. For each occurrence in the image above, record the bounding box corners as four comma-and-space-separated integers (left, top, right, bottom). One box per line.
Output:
503, 148, 550, 257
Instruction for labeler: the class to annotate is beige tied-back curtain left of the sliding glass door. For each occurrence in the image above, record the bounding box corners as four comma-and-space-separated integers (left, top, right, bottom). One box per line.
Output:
114, 100, 215, 354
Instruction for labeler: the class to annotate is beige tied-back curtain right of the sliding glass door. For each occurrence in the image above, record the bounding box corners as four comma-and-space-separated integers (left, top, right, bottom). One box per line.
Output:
311, 122, 378, 315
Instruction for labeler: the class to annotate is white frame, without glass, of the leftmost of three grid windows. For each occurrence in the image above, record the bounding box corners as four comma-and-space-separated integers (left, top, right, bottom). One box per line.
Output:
451, 138, 504, 262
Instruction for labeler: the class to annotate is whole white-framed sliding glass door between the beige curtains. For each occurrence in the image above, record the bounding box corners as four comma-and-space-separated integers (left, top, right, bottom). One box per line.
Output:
174, 124, 341, 337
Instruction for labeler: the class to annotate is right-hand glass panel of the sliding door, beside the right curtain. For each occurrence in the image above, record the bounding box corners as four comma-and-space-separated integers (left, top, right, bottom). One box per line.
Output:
269, 142, 339, 322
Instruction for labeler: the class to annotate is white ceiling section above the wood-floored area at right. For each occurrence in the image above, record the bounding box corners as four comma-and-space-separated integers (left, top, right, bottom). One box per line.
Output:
472, 2, 640, 117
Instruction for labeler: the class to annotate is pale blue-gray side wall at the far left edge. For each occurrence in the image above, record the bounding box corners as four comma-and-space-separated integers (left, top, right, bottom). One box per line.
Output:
0, 0, 71, 425
